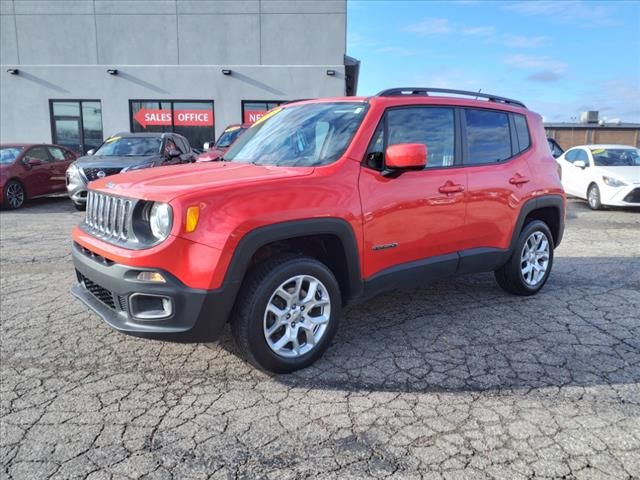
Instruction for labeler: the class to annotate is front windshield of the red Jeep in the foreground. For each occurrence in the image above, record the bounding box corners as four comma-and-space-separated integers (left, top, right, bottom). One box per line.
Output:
223, 102, 367, 167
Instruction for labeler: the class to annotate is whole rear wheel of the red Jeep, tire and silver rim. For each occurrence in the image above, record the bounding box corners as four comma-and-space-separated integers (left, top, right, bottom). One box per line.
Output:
495, 220, 554, 296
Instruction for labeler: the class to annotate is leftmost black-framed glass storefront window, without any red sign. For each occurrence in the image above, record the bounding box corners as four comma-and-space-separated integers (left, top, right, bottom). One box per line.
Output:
50, 100, 102, 153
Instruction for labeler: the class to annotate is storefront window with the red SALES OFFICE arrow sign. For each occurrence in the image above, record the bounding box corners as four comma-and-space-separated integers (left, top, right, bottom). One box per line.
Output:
129, 100, 215, 149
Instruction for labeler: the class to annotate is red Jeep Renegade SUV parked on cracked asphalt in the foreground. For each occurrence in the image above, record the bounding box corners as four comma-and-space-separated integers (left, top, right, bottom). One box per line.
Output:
73, 88, 565, 372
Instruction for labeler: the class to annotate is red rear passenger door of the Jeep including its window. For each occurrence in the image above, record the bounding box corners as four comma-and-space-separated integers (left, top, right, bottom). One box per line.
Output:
461, 108, 533, 253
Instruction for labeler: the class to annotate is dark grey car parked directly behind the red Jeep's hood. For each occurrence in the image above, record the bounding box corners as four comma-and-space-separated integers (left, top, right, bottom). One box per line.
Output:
66, 132, 197, 210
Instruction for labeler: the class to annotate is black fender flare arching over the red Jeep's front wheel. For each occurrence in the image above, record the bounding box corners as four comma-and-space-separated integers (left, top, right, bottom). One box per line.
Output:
223, 218, 363, 303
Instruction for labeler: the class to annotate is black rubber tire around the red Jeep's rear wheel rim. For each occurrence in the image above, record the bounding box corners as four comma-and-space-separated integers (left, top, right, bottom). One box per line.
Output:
494, 220, 555, 296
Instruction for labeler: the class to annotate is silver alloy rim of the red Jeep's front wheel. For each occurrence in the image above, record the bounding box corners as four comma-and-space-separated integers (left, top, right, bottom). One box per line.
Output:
263, 275, 331, 358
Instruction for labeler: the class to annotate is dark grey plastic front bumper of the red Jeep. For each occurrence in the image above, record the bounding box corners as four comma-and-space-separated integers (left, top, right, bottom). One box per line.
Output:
71, 243, 233, 342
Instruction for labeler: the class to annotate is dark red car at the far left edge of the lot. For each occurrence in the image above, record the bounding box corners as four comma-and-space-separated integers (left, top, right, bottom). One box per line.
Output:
0, 143, 78, 209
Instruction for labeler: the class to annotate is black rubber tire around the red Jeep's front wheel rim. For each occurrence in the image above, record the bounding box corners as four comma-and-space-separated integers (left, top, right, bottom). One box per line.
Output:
231, 255, 342, 373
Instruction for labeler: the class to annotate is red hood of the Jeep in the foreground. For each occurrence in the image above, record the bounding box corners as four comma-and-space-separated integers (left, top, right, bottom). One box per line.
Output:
91, 162, 314, 202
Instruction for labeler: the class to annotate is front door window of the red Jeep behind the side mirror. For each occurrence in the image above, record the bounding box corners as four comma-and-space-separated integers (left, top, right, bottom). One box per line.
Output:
386, 107, 455, 168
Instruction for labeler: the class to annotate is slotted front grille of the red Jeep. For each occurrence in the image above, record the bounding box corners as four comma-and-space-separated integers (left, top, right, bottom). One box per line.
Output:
85, 190, 133, 241
